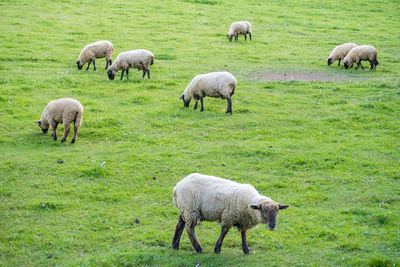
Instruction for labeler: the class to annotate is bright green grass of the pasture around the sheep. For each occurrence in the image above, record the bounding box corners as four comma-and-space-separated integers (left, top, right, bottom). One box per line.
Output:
0, 0, 400, 266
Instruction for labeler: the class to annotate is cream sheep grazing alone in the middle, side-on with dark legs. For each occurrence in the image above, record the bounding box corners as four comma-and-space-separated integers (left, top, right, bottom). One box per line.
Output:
180, 71, 237, 114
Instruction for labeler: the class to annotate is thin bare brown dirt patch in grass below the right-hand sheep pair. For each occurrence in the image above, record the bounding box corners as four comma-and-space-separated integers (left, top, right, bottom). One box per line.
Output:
254, 72, 359, 82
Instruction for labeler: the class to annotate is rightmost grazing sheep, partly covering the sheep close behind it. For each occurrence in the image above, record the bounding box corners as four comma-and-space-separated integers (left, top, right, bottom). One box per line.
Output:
343, 45, 379, 70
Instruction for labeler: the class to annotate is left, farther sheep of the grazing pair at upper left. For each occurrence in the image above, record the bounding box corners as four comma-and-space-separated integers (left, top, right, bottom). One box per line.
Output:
76, 41, 114, 70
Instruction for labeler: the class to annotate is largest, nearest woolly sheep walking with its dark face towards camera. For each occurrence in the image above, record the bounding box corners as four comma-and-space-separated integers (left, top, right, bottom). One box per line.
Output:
171, 173, 289, 254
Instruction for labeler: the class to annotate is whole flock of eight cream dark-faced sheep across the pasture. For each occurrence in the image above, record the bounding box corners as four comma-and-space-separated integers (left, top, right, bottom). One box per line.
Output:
36, 21, 379, 254
